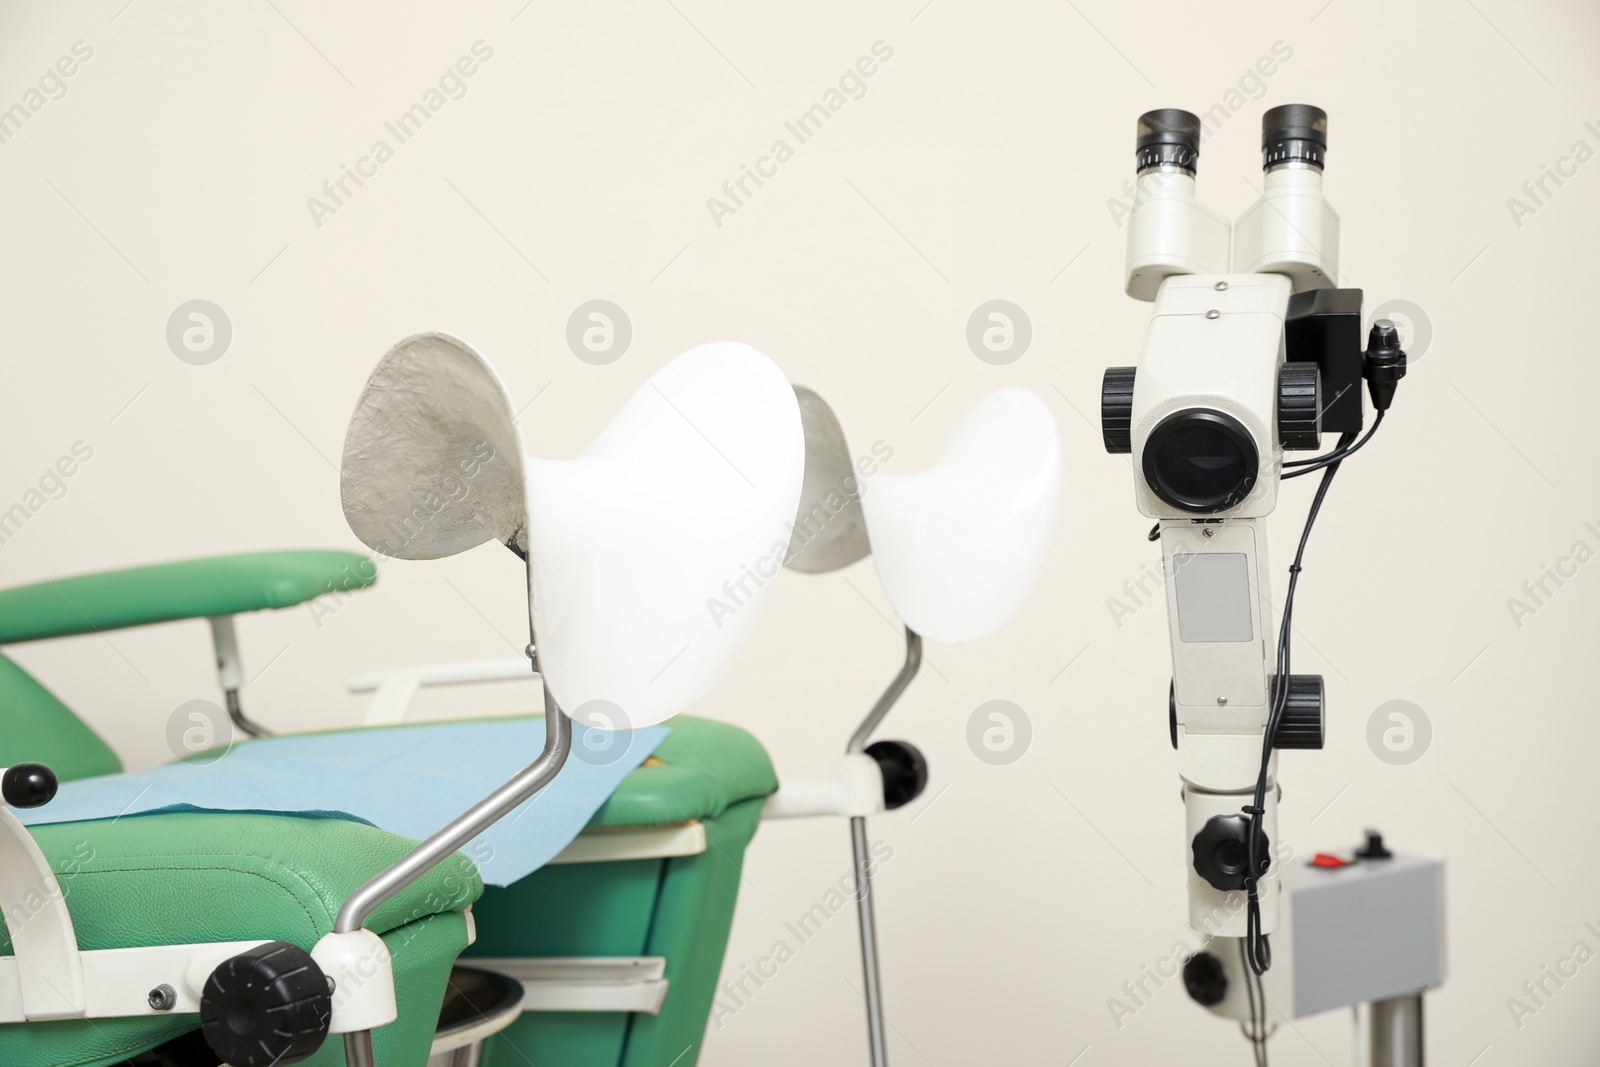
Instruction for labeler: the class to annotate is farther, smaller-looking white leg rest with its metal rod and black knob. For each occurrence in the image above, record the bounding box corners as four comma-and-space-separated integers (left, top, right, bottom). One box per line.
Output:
763, 386, 1061, 1067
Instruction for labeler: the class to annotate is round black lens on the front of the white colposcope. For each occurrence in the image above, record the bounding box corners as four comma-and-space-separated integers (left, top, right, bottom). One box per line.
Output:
1141, 408, 1261, 515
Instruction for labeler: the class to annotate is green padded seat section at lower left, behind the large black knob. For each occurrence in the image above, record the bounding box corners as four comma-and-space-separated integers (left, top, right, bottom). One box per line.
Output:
0, 813, 483, 1067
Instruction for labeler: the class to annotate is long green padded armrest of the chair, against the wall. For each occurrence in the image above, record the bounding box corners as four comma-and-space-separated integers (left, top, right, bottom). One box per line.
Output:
0, 549, 378, 645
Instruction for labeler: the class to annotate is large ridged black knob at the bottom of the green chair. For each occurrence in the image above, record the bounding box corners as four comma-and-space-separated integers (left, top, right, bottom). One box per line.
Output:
200, 941, 333, 1067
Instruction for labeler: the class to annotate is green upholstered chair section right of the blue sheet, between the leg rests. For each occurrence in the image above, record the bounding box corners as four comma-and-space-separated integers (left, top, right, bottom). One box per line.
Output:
464, 715, 778, 1067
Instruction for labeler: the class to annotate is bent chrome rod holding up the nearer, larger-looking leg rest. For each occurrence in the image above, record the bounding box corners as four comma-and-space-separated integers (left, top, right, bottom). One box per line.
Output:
333, 686, 573, 1067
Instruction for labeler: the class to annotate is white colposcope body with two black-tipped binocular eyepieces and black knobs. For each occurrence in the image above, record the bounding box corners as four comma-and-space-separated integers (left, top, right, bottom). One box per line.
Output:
1101, 106, 1339, 937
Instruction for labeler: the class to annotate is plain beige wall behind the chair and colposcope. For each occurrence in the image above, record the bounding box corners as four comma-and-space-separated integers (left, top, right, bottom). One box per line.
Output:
0, 0, 1600, 1067
